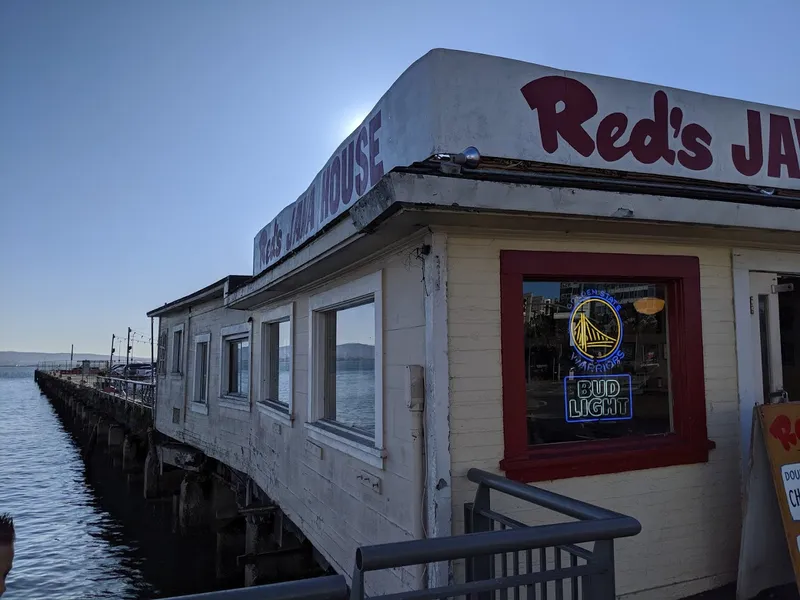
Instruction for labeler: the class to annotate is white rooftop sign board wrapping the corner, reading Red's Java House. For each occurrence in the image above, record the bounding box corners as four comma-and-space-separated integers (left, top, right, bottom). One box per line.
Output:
253, 50, 800, 274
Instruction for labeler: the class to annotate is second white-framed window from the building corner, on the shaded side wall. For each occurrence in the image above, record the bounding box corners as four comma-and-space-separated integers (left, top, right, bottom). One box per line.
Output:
258, 304, 294, 425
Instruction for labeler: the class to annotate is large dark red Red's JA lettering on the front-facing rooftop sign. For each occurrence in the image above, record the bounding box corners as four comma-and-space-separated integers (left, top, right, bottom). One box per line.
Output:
522, 76, 800, 179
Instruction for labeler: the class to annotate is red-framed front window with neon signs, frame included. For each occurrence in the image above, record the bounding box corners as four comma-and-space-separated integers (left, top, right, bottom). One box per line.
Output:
501, 251, 709, 481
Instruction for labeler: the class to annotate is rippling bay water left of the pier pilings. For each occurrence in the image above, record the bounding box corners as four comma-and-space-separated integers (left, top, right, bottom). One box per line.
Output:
0, 367, 216, 600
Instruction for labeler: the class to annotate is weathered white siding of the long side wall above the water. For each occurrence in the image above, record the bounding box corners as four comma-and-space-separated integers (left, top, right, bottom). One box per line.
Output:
157, 238, 425, 594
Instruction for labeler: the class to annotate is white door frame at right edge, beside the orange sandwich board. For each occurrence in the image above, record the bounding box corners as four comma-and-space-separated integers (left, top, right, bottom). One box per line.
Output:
731, 248, 800, 491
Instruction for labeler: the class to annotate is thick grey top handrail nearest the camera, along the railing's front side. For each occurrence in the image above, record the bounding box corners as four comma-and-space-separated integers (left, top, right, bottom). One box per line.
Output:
356, 515, 642, 571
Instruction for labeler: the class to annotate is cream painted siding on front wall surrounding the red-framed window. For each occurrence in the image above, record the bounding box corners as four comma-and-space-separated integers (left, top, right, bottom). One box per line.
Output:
447, 233, 740, 599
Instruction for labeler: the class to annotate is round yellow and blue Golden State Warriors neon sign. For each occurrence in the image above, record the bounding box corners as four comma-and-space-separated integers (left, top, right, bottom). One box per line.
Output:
569, 290, 625, 373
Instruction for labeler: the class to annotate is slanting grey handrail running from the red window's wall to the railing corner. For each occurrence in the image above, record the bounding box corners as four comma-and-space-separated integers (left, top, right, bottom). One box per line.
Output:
467, 468, 642, 524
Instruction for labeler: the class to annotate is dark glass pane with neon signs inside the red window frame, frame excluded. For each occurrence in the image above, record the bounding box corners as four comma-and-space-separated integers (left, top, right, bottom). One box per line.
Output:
523, 281, 672, 444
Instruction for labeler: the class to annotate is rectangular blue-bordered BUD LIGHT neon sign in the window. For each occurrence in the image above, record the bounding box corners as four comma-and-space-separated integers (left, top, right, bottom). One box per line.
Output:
564, 373, 633, 423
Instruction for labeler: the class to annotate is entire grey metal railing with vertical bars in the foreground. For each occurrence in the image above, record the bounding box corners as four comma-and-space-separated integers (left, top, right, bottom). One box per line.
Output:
159, 469, 642, 600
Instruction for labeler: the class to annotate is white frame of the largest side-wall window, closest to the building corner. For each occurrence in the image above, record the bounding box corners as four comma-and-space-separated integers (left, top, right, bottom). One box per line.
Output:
305, 270, 386, 469
